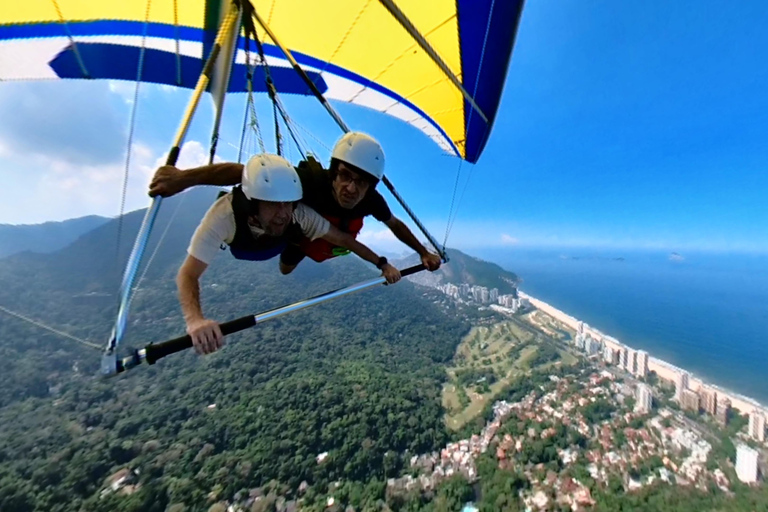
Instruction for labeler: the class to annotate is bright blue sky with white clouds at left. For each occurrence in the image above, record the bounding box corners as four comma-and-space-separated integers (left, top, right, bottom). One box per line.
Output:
0, 0, 768, 252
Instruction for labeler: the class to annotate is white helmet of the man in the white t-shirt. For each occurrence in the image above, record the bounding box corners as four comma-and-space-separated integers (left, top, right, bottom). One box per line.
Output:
243, 153, 302, 203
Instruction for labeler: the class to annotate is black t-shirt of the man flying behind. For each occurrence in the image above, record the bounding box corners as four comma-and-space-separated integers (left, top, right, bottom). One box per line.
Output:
296, 162, 392, 222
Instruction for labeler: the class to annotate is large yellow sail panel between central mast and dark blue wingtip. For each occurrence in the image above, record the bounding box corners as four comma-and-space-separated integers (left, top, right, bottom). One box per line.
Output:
254, 0, 464, 156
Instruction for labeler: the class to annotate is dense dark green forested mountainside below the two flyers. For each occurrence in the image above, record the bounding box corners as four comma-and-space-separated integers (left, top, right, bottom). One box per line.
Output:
0, 190, 468, 512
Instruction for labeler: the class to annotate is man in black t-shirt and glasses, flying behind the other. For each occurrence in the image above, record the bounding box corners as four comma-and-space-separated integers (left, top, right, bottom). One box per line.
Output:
149, 132, 441, 274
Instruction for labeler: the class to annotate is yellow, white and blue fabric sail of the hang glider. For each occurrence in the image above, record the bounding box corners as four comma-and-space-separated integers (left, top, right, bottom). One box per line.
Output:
0, 0, 523, 163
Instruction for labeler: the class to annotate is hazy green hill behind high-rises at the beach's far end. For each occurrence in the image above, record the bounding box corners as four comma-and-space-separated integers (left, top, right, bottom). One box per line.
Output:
399, 249, 519, 294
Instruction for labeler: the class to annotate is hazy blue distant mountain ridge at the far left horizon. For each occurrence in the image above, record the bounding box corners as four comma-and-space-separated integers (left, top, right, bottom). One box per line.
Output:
0, 215, 111, 258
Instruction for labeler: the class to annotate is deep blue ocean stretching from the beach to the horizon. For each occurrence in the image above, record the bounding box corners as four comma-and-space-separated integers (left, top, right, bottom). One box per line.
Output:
478, 249, 768, 404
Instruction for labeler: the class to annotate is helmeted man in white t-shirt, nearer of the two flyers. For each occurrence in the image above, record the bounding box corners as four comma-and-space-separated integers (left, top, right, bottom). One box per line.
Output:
176, 154, 400, 354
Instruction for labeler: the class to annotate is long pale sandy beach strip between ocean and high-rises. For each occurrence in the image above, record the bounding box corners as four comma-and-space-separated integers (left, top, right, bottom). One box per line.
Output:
518, 290, 768, 420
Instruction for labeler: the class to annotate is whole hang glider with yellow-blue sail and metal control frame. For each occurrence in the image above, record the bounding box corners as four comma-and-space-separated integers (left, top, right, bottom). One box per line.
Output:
0, 0, 523, 375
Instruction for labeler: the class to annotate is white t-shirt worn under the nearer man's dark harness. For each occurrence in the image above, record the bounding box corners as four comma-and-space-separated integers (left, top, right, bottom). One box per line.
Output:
187, 194, 331, 264
